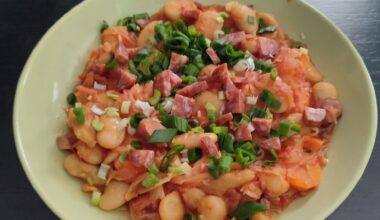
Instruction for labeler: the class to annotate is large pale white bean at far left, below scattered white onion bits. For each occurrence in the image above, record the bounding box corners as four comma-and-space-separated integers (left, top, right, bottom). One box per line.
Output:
96, 115, 125, 149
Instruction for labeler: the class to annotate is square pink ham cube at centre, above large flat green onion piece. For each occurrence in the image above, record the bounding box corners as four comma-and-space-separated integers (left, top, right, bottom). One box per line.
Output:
171, 94, 195, 118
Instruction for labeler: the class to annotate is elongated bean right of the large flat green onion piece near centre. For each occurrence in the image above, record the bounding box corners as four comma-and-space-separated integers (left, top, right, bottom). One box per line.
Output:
172, 132, 218, 149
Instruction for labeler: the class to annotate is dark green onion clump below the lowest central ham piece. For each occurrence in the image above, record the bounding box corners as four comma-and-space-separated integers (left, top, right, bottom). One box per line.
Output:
207, 155, 233, 179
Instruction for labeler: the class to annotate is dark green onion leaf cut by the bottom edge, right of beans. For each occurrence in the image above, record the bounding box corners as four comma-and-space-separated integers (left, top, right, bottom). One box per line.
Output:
229, 202, 267, 220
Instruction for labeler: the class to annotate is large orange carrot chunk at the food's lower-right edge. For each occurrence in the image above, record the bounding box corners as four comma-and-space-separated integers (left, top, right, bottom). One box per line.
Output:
287, 163, 321, 191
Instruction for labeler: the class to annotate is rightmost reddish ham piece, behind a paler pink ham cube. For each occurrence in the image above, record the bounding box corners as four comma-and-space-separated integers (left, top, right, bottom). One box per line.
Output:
317, 98, 342, 124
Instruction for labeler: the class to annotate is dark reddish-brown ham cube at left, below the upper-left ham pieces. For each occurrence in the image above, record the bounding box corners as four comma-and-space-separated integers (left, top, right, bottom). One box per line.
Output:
107, 67, 137, 91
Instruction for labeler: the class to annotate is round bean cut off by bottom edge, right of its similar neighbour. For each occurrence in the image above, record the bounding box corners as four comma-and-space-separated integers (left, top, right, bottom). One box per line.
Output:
198, 196, 227, 220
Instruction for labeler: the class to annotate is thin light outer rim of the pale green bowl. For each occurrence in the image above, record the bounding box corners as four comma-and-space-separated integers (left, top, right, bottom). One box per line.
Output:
13, 1, 378, 219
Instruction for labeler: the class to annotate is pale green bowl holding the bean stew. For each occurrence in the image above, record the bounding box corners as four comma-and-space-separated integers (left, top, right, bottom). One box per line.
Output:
13, 0, 377, 220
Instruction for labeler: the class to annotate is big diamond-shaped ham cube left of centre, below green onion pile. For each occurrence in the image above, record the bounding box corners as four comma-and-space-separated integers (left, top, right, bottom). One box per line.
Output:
154, 70, 182, 96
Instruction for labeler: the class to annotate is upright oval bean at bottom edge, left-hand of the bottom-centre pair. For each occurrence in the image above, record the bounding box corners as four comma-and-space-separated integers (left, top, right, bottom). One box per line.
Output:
158, 191, 185, 220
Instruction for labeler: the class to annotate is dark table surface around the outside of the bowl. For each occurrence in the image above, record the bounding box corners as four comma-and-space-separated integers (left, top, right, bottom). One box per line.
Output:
0, 0, 380, 220
